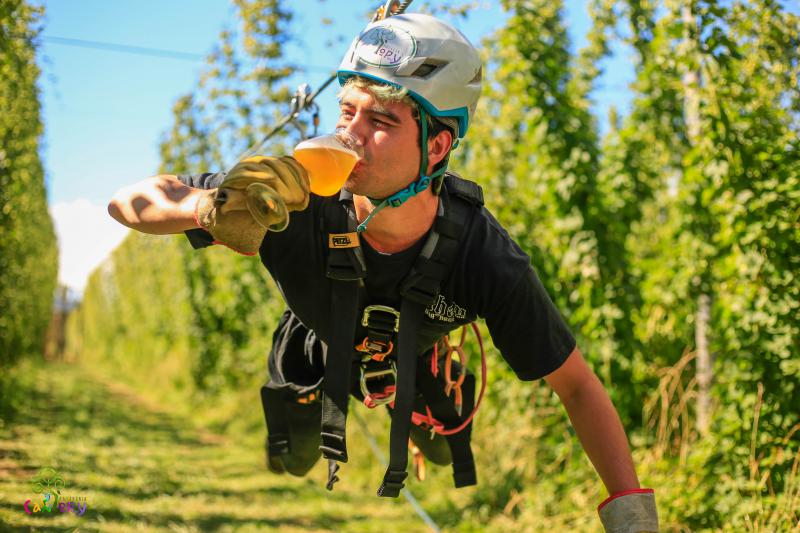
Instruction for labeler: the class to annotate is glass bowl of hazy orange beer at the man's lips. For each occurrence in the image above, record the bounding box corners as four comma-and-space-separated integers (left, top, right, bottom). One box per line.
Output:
293, 128, 364, 196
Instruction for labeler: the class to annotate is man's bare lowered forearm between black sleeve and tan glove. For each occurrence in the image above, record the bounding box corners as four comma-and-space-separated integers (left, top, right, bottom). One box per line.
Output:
561, 375, 639, 494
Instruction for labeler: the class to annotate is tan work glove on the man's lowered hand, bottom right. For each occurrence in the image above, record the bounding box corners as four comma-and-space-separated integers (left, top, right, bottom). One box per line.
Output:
597, 489, 658, 533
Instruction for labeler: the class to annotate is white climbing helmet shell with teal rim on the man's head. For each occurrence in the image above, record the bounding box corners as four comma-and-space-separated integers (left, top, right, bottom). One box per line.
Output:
337, 13, 482, 138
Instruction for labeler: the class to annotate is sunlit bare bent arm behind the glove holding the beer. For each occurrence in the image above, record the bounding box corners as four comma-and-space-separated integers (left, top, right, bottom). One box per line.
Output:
108, 175, 204, 235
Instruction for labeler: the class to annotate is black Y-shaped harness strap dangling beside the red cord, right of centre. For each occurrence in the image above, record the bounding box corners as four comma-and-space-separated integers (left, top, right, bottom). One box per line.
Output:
417, 368, 478, 488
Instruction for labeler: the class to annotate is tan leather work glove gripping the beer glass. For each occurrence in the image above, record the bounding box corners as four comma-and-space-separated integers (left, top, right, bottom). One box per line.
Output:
195, 156, 309, 255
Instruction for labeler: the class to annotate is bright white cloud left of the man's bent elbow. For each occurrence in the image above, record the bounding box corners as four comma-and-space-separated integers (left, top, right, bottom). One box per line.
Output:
50, 198, 128, 293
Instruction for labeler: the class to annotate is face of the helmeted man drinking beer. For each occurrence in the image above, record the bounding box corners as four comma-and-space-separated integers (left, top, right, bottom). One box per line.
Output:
336, 88, 420, 198
